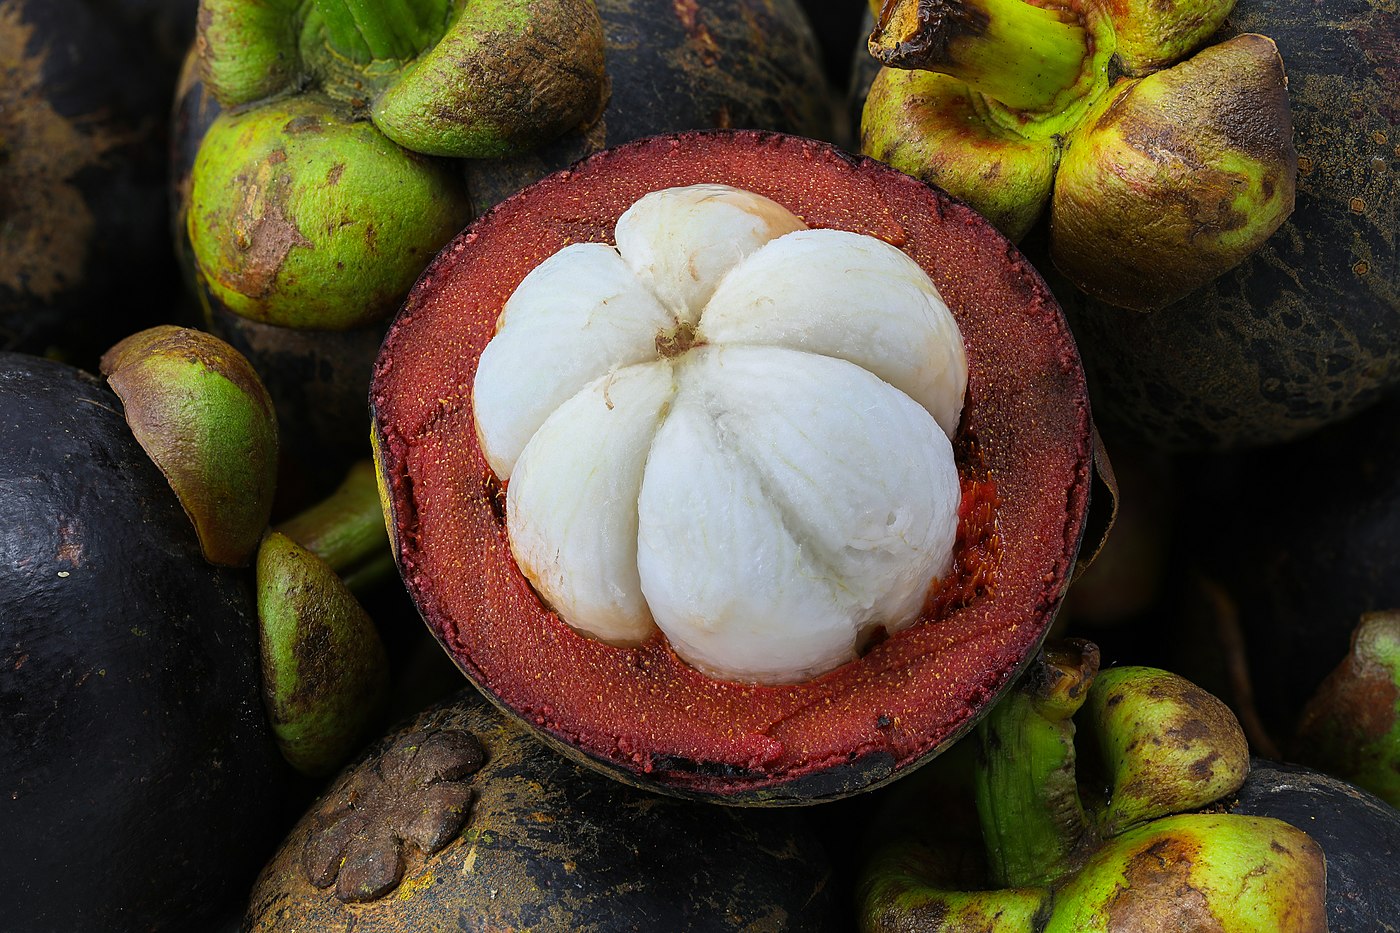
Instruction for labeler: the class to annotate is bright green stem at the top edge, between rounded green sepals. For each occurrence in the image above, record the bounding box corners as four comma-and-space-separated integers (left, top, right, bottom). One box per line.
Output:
314, 0, 451, 64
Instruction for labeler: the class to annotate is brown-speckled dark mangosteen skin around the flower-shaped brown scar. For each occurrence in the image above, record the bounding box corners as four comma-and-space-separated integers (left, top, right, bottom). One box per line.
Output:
245, 691, 844, 933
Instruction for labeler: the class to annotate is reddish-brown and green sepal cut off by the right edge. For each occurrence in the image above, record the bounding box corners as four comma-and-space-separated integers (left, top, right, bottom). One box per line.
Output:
1295, 609, 1400, 807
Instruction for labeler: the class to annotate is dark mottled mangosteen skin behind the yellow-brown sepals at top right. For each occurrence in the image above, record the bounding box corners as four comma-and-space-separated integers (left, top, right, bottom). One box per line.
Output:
1058, 0, 1400, 450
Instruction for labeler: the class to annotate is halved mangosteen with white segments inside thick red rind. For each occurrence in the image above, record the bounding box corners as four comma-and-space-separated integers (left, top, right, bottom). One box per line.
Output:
371, 130, 1095, 804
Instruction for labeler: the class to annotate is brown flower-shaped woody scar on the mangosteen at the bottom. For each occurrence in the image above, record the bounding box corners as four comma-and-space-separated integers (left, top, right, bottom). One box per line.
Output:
301, 728, 486, 904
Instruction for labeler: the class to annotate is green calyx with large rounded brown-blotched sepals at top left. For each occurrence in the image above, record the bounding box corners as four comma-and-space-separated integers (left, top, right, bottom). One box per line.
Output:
188, 0, 606, 331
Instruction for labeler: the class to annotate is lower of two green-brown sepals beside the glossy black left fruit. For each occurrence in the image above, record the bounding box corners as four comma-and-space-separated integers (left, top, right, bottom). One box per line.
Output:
256, 531, 389, 776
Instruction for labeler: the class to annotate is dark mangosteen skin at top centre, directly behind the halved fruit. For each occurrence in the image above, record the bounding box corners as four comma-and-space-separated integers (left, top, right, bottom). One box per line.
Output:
466, 0, 833, 214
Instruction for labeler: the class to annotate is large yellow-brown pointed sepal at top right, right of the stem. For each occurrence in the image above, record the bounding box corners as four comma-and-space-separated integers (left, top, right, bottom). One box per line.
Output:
1050, 34, 1298, 311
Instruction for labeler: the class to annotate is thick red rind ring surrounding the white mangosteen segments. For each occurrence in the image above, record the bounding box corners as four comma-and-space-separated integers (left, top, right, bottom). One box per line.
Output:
371, 132, 1092, 794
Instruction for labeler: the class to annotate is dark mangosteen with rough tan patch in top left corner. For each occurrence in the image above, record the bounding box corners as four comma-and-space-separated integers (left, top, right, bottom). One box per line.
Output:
0, 0, 195, 364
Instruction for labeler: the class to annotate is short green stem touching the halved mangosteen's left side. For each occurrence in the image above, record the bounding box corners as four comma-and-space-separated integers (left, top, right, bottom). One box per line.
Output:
277, 461, 393, 593
